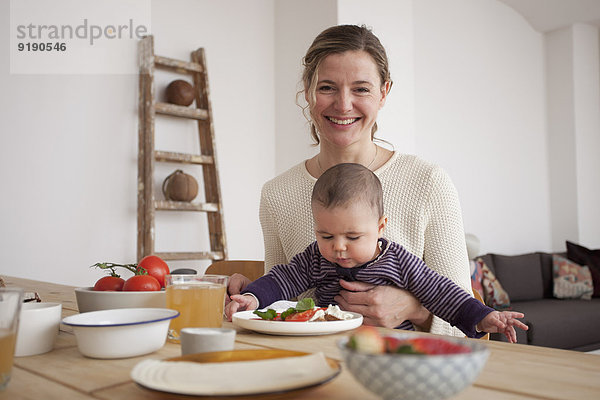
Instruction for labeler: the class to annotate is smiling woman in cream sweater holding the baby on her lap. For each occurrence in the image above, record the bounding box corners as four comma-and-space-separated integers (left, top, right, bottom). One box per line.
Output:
229, 25, 471, 336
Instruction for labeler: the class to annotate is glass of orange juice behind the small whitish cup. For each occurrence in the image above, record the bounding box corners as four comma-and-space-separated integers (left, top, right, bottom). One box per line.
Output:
165, 275, 229, 343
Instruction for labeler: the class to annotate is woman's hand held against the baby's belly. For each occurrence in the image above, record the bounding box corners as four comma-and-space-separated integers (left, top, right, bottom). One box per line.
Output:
334, 279, 433, 331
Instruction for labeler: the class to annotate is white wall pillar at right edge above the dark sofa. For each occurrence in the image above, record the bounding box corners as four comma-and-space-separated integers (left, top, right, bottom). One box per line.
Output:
546, 24, 600, 248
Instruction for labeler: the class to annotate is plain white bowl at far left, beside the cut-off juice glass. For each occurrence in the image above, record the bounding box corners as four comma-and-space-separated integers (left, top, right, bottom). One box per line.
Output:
15, 303, 62, 357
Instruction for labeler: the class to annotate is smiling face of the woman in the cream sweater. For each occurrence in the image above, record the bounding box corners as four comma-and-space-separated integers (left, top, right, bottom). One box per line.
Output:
307, 51, 389, 147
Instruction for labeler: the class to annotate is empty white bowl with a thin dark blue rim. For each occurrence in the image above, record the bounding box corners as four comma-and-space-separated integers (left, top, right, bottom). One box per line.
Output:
62, 308, 179, 358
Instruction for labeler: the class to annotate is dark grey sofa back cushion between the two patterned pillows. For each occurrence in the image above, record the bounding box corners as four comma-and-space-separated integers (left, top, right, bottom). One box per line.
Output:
493, 253, 544, 302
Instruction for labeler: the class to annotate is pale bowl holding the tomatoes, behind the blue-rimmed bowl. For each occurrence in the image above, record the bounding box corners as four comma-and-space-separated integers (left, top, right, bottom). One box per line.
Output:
75, 287, 167, 313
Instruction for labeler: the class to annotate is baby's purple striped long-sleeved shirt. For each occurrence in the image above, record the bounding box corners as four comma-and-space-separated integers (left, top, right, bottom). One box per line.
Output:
243, 239, 493, 337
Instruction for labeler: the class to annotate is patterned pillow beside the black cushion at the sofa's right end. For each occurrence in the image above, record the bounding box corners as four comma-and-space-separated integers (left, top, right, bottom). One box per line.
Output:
552, 254, 594, 300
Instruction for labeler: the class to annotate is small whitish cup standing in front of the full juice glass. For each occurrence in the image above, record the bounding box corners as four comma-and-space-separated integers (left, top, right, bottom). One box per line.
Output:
181, 328, 235, 355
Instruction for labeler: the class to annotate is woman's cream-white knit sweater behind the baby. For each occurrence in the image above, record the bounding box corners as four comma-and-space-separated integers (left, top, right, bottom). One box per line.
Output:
260, 152, 471, 336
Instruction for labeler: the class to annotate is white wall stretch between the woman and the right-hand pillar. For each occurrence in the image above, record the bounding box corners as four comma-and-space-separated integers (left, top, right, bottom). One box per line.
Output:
414, 0, 550, 254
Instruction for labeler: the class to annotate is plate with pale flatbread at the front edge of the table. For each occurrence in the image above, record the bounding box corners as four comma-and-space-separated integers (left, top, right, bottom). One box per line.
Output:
131, 349, 341, 397
